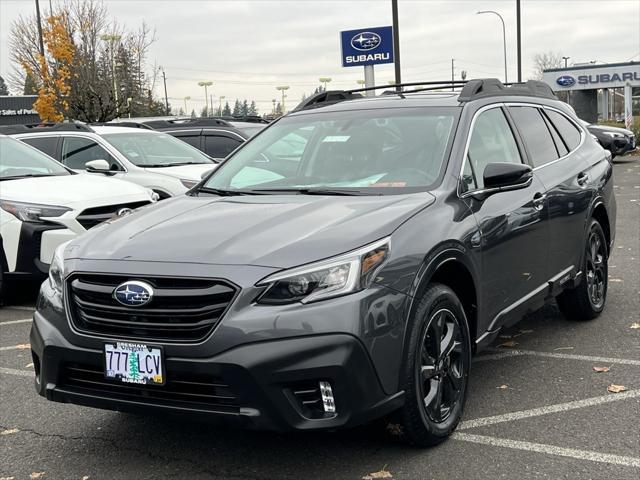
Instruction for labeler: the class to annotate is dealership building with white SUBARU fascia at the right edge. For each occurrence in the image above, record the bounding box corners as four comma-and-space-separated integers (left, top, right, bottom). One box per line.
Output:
543, 62, 640, 128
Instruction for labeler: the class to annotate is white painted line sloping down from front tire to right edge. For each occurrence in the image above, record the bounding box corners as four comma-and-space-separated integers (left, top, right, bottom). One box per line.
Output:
451, 432, 640, 468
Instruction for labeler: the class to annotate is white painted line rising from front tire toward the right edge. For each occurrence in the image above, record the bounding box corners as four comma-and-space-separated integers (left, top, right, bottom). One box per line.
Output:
458, 390, 640, 430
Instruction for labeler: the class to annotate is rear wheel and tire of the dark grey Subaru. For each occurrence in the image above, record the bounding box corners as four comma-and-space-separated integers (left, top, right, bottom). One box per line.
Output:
556, 219, 609, 321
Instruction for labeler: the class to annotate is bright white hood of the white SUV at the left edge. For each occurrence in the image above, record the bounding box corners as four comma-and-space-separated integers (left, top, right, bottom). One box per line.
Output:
0, 173, 151, 207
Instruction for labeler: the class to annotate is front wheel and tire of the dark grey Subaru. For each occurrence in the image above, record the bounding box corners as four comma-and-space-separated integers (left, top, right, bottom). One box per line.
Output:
400, 283, 471, 447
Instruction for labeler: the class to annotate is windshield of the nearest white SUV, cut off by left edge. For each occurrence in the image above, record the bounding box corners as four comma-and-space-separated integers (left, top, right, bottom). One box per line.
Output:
0, 137, 71, 180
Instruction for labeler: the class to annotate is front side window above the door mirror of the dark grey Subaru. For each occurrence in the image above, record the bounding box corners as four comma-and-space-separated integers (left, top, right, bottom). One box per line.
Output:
463, 108, 522, 190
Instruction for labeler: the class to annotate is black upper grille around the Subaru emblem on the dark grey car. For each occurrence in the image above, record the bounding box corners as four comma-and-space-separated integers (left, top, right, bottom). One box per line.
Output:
67, 274, 237, 343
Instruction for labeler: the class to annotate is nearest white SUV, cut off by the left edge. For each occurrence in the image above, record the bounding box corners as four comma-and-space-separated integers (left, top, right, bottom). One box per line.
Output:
0, 135, 157, 299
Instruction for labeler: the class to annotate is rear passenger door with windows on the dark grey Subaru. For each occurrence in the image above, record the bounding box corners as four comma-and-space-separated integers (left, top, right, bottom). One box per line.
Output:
509, 105, 591, 279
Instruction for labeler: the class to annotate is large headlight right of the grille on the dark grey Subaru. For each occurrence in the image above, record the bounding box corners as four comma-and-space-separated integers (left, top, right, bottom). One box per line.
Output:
258, 238, 389, 305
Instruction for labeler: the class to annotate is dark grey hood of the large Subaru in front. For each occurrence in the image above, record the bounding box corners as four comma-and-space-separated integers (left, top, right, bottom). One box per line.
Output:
72, 193, 435, 268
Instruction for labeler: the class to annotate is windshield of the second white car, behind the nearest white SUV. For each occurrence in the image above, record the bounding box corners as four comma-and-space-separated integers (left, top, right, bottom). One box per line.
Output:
103, 132, 215, 167
